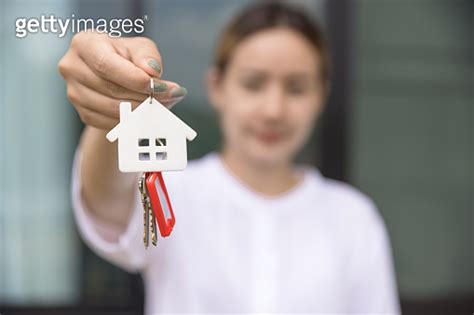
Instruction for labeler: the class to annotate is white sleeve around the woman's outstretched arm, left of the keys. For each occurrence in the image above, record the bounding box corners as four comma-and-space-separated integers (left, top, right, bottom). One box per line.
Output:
71, 149, 147, 272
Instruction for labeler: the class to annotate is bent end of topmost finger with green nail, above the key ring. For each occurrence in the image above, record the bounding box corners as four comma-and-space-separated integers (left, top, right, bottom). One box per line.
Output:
122, 37, 163, 78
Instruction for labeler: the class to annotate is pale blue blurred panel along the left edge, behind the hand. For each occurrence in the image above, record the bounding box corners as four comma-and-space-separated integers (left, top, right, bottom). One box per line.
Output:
0, 1, 80, 305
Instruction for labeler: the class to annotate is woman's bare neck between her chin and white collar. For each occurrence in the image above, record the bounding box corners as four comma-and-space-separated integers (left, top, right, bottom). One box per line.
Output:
221, 149, 302, 196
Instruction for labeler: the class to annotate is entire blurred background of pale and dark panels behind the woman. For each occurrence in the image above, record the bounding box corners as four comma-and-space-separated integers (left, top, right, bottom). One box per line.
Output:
0, 0, 474, 314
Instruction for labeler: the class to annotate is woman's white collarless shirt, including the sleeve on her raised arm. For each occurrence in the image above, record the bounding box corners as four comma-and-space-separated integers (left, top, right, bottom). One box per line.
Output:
72, 151, 400, 314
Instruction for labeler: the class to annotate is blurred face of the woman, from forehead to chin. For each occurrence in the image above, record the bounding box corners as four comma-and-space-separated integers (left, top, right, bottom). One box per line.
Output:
209, 28, 325, 167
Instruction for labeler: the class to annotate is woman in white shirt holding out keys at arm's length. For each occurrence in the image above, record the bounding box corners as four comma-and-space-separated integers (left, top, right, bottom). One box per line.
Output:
59, 2, 399, 314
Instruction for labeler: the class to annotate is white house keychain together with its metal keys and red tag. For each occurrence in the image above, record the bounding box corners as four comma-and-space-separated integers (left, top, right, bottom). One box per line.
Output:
106, 91, 197, 247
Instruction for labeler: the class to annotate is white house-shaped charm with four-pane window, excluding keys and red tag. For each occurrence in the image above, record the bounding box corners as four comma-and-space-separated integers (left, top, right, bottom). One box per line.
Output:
107, 97, 197, 172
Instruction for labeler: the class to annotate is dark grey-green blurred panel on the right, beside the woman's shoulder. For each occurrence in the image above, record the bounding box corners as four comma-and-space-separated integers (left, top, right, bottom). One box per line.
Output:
350, 1, 474, 304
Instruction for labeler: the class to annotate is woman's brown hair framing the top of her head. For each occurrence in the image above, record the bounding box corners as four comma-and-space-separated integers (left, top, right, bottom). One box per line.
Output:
214, 1, 330, 81
